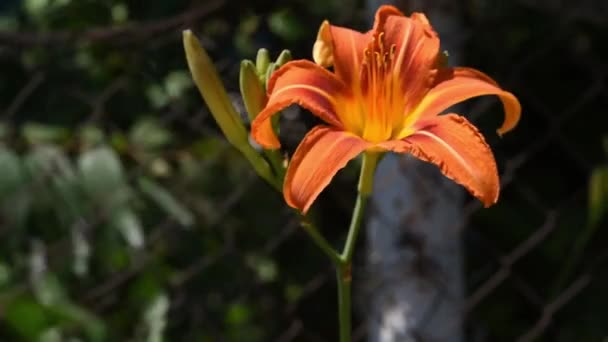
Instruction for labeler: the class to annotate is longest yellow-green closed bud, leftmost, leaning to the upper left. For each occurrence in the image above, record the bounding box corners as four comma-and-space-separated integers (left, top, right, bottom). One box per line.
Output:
183, 30, 249, 149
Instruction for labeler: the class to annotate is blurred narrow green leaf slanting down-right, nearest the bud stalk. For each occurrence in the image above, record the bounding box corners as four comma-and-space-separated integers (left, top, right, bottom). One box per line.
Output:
137, 177, 194, 227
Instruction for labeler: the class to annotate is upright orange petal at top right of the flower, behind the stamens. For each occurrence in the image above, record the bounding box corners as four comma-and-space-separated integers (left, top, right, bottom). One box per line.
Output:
376, 13, 439, 108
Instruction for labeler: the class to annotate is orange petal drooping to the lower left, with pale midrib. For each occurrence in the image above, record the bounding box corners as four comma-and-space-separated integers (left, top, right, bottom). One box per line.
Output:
283, 126, 370, 213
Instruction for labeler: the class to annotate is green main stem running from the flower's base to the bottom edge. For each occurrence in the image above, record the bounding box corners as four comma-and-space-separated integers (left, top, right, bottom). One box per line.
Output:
336, 152, 380, 342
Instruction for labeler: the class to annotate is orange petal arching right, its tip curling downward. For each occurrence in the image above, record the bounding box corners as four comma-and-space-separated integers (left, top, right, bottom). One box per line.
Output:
414, 67, 521, 135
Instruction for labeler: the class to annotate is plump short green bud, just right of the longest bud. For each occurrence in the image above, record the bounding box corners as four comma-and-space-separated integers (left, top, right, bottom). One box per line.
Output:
239, 59, 266, 122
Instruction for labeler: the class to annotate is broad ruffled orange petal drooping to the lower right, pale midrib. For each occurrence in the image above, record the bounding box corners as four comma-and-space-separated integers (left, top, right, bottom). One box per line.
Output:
379, 114, 500, 207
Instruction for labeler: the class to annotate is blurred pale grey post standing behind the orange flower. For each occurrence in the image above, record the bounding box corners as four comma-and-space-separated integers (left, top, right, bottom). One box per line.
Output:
364, 0, 465, 342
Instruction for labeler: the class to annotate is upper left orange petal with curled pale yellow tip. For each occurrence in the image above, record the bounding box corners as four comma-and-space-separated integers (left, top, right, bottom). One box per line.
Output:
313, 20, 372, 85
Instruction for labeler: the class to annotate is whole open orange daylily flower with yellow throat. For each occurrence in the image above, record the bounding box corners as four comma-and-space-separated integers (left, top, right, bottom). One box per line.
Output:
252, 6, 521, 212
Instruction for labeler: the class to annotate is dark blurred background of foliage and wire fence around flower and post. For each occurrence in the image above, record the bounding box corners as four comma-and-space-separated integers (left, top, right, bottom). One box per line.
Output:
0, 0, 608, 342
